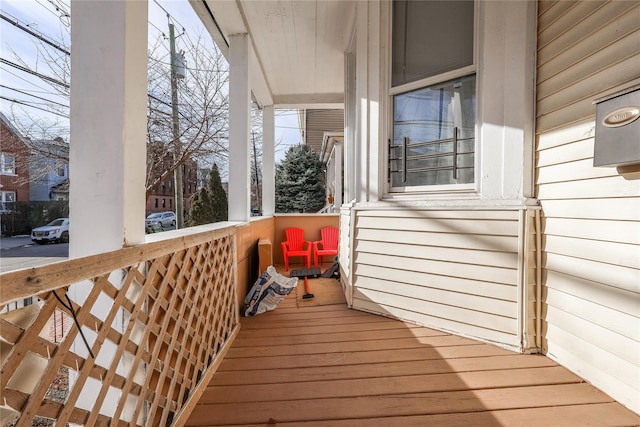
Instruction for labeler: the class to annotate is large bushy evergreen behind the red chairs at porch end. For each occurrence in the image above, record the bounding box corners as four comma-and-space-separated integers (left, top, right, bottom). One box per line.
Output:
276, 144, 325, 213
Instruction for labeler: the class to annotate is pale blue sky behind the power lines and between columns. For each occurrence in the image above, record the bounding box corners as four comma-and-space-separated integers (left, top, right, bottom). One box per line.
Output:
0, 0, 301, 161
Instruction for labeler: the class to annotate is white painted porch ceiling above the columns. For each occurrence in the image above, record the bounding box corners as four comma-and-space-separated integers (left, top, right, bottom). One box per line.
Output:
190, 0, 355, 108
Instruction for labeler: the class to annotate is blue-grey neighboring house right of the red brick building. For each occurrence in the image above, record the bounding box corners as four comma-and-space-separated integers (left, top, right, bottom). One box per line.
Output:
29, 138, 69, 202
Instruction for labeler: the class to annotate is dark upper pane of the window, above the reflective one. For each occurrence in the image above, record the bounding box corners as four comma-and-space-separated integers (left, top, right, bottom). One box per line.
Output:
391, 0, 474, 86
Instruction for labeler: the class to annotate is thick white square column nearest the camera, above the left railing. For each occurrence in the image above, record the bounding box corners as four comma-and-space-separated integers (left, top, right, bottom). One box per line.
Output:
69, 1, 148, 258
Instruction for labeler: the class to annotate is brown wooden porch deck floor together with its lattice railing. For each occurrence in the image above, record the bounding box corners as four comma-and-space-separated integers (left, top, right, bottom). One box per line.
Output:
0, 219, 640, 426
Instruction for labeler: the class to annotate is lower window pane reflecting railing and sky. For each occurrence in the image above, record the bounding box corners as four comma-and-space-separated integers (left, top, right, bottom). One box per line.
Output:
389, 75, 476, 187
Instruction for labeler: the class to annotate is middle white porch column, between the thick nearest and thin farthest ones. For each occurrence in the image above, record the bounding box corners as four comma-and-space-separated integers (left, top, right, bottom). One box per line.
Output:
229, 34, 251, 222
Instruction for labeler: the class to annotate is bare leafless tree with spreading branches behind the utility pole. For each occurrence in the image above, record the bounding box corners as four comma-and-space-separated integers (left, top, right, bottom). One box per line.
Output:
146, 30, 229, 201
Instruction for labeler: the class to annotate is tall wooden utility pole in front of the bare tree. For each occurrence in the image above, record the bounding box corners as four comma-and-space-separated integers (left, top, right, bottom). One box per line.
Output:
169, 23, 184, 228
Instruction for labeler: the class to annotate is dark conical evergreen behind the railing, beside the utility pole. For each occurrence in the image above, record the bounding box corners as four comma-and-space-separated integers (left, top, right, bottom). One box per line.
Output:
187, 164, 229, 226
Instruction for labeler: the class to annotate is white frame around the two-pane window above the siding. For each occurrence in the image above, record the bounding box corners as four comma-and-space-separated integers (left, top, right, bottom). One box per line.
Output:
383, 0, 481, 199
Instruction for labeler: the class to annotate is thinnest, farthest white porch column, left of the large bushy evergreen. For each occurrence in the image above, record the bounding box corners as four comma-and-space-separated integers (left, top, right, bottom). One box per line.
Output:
262, 105, 276, 216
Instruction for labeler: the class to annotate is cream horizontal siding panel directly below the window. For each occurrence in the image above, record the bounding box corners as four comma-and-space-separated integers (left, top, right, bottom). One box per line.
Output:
352, 209, 536, 351
